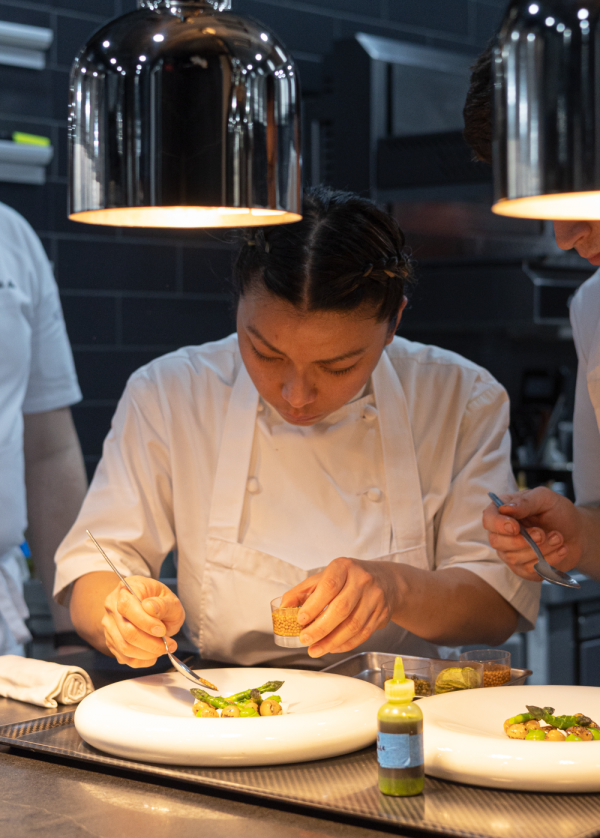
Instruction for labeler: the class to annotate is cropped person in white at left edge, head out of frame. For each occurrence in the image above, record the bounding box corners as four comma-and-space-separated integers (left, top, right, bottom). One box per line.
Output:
0, 204, 86, 654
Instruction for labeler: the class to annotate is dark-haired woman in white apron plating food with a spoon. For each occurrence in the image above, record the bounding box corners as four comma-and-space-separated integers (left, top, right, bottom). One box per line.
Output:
55, 189, 539, 667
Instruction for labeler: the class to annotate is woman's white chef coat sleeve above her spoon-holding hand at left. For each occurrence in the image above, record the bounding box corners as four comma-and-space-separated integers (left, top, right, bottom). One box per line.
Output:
54, 367, 175, 603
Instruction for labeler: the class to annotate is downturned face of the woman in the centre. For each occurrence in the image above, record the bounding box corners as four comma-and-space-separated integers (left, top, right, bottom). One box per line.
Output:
237, 290, 406, 425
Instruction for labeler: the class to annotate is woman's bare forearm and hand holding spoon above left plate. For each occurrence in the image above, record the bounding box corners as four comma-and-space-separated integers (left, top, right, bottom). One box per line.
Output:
71, 570, 185, 668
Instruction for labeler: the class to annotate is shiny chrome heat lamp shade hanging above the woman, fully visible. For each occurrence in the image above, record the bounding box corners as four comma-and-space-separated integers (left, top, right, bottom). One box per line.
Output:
69, 0, 301, 227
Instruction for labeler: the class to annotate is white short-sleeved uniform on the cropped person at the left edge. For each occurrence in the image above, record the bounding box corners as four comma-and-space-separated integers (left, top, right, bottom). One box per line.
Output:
0, 203, 81, 654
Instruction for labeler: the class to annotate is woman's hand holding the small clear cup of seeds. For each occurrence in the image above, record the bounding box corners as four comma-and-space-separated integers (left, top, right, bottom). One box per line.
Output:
281, 558, 395, 658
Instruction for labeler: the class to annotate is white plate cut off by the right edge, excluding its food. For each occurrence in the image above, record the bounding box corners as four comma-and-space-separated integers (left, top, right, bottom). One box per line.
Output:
419, 686, 600, 792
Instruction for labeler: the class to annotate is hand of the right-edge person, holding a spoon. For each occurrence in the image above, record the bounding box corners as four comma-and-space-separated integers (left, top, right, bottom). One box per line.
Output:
483, 486, 582, 582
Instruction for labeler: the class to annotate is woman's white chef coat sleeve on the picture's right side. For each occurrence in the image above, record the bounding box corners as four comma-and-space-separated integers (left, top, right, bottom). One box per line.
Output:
435, 378, 541, 631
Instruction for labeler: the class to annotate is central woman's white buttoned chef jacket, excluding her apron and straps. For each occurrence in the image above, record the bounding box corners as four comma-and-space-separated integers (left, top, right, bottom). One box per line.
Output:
55, 335, 539, 643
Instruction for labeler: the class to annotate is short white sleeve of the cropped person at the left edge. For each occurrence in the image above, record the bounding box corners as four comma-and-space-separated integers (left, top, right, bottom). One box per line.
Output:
21, 219, 81, 413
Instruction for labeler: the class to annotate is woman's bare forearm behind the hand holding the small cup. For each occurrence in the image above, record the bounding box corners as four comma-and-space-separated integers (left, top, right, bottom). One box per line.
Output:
389, 564, 518, 646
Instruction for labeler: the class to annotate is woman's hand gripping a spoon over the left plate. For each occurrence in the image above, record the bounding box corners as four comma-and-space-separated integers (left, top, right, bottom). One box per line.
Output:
102, 576, 185, 668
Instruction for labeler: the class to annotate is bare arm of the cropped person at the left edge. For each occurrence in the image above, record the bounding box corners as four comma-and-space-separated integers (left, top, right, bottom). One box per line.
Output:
23, 407, 87, 632
